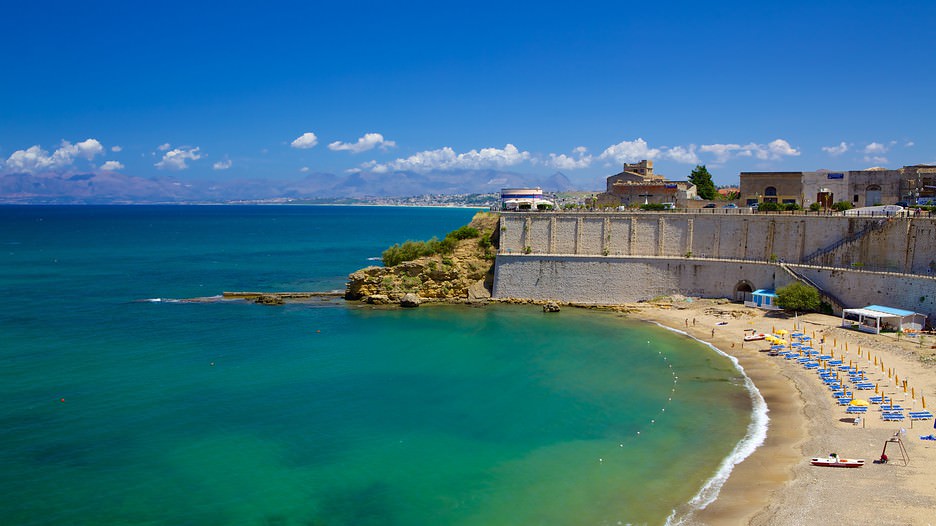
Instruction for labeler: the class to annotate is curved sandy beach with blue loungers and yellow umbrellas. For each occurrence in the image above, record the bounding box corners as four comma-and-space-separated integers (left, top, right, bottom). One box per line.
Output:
629, 298, 936, 525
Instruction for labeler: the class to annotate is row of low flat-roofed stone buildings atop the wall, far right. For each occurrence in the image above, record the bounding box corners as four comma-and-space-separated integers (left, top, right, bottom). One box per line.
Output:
741, 165, 936, 208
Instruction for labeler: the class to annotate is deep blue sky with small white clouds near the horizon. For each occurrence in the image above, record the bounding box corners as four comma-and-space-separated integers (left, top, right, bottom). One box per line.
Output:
0, 1, 936, 189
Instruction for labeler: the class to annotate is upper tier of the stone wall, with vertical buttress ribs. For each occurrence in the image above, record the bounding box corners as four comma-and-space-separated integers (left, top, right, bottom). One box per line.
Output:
500, 210, 936, 274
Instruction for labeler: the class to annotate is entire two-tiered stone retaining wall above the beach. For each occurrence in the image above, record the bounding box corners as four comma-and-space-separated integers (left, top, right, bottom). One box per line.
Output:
493, 212, 936, 323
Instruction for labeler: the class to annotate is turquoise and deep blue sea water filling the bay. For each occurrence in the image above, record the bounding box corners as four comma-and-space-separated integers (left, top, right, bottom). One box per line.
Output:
0, 207, 759, 525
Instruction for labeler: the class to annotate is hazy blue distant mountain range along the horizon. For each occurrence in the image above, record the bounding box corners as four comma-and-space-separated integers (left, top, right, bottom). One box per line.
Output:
0, 170, 576, 204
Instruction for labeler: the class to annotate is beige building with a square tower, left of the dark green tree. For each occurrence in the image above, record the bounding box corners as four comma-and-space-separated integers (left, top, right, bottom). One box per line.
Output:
597, 160, 696, 207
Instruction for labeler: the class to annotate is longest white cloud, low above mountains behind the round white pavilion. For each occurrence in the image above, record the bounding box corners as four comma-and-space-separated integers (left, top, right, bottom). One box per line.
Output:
361, 144, 531, 173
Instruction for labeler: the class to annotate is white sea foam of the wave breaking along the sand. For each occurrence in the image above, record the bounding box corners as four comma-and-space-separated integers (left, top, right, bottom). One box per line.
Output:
657, 323, 770, 526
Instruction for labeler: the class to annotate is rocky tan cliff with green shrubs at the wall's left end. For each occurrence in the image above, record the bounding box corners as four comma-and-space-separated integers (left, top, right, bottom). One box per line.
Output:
345, 212, 500, 306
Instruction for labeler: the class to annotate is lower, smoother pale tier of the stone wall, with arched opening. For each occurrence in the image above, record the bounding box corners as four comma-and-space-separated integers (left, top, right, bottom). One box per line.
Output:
493, 254, 936, 322
